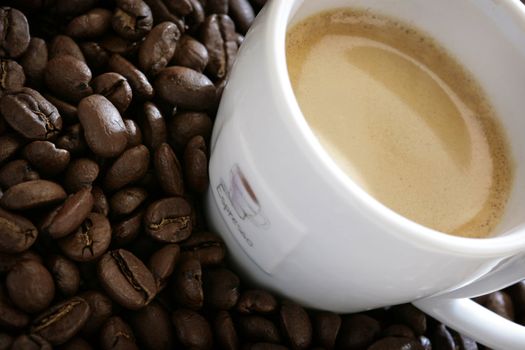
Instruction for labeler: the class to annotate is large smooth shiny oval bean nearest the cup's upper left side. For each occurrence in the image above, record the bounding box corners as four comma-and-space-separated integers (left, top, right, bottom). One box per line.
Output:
155, 66, 215, 111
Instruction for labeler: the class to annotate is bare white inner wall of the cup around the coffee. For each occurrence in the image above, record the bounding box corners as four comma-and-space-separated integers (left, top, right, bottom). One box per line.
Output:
278, 0, 525, 243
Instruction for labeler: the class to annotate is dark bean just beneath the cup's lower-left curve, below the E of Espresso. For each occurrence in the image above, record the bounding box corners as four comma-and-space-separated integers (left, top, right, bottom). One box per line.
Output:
203, 268, 240, 310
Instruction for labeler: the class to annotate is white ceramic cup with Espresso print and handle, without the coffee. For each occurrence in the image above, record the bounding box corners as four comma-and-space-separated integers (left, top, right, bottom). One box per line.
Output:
206, 0, 525, 350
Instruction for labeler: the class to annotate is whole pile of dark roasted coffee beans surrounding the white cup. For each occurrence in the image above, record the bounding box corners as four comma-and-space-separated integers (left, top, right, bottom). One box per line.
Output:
0, 0, 525, 350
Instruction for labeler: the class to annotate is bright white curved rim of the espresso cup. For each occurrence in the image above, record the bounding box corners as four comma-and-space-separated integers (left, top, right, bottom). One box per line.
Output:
266, 0, 525, 257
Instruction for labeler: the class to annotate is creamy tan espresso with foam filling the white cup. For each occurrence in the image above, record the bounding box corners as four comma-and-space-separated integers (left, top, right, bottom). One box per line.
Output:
286, 9, 513, 237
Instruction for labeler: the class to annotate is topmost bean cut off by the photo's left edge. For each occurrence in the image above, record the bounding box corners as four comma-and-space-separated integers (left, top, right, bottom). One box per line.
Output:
0, 7, 31, 58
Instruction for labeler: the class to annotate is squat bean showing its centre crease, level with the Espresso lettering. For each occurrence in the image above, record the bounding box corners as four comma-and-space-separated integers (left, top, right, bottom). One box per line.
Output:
144, 197, 191, 243
